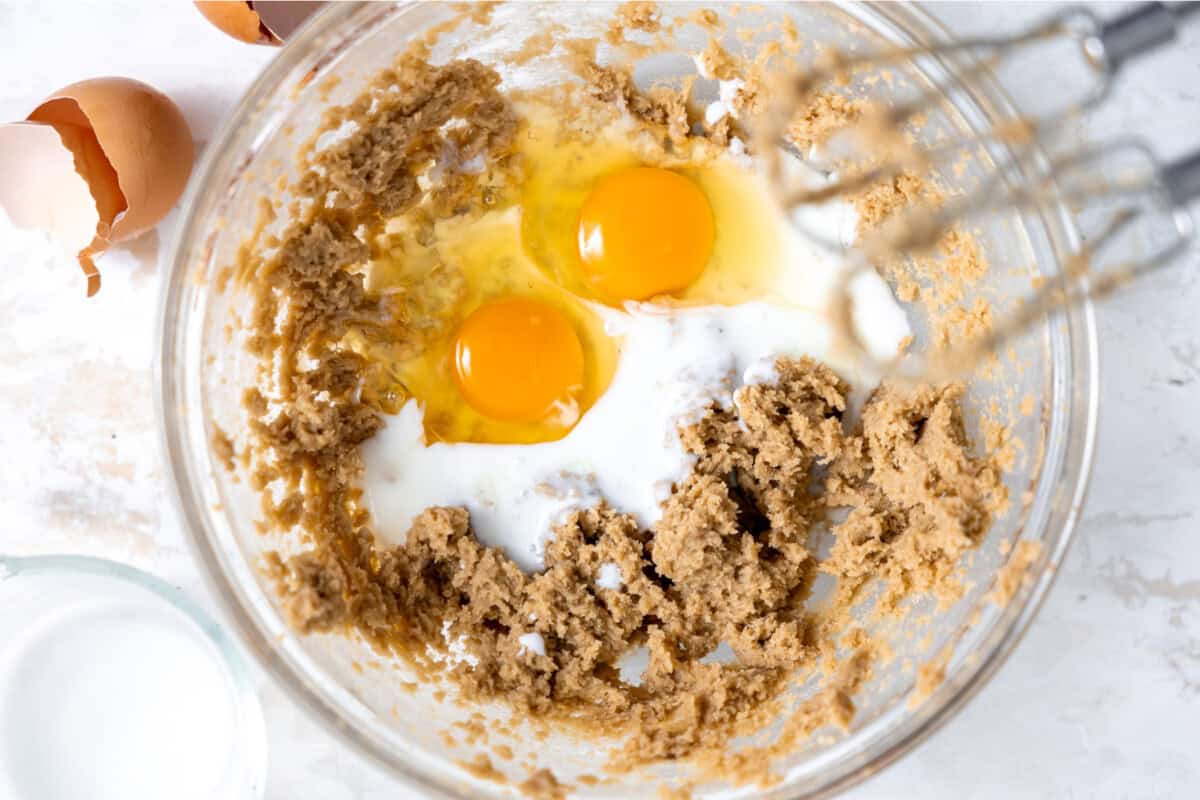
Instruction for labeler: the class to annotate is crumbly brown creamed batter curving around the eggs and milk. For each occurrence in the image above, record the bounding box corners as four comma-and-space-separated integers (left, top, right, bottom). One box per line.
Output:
222, 21, 1006, 795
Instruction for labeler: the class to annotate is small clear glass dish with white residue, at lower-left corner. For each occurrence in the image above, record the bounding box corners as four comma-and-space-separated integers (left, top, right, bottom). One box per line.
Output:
0, 555, 266, 800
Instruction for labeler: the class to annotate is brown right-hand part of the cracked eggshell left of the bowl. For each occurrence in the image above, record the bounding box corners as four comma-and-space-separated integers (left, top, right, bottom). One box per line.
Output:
29, 78, 194, 247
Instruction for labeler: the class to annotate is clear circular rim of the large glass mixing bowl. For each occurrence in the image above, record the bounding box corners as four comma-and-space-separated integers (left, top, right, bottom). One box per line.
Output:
155, 2, 1098, 799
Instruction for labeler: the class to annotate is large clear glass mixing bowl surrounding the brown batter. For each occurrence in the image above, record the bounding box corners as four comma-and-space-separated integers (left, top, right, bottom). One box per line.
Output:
158, 2, 1097, 798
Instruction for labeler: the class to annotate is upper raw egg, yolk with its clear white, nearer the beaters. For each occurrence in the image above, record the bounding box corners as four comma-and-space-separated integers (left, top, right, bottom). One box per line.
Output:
521, 112, 823, 307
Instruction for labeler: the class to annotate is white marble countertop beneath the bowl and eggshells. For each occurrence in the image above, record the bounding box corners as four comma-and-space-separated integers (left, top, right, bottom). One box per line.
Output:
0, 0, 1200, 800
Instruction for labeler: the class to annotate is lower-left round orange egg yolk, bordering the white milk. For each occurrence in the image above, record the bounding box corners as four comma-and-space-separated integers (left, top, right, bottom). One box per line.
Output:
454, 297, 584, 425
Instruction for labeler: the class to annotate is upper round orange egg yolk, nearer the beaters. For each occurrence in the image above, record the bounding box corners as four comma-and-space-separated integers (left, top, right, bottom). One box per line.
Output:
578, 167, 715, 301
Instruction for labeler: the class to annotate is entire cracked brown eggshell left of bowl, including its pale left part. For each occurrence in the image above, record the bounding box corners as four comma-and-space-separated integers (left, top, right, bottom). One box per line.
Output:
0, 78, 194, 296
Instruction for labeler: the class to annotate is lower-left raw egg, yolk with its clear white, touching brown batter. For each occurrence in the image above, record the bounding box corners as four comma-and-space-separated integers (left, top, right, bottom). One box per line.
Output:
352, 207, 617, 443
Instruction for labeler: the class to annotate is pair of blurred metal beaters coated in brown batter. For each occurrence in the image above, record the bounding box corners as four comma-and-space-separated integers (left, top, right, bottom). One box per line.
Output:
754, 1, 1200, 379
